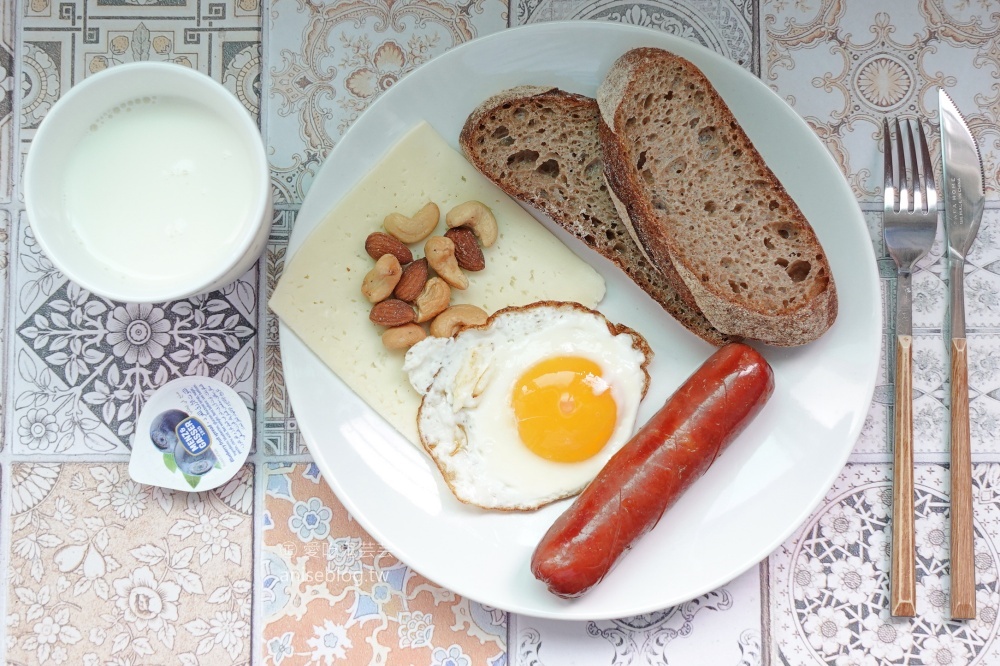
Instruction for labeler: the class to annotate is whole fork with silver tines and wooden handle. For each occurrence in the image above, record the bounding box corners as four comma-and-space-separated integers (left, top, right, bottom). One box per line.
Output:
882, 118, 938, 617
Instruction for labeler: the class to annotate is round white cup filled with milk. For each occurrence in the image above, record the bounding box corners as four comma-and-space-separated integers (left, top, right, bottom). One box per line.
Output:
24, 62, 272, 303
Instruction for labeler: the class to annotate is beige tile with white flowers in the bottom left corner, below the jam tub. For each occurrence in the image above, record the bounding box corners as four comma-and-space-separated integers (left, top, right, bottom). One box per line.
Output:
6, 463, 254, 664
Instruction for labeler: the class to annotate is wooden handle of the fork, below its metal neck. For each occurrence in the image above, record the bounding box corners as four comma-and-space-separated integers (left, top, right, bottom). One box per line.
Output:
889, 335, 917, 617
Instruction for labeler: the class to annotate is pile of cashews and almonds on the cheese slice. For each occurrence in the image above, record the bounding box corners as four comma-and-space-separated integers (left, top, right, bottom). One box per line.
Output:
361, 201, 499, 350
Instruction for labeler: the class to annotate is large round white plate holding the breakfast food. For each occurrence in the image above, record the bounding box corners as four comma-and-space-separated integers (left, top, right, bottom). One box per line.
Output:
281, 22, 881, 620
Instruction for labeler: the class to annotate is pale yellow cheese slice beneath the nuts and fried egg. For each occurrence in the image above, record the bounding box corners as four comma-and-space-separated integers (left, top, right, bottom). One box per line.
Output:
269, 123, 605, 446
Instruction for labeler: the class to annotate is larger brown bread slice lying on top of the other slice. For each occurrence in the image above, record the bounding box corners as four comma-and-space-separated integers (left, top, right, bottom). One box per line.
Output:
597, 48, 837, 346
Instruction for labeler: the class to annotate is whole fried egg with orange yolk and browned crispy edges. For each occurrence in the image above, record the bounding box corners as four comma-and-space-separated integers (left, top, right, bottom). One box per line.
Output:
403, 301, 652, 510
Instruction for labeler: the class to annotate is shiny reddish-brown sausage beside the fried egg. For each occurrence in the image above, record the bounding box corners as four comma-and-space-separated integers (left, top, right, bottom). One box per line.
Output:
531, 343, 774, 597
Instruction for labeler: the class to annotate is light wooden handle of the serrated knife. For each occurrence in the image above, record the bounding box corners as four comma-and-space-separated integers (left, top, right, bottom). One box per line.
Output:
951, 338, 976, 620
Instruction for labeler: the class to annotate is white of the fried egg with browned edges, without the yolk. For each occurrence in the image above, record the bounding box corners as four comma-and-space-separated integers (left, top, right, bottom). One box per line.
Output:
403, 302, 652, 510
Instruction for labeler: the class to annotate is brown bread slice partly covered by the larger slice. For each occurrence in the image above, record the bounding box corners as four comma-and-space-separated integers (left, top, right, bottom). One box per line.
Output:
459, 86, 735, 346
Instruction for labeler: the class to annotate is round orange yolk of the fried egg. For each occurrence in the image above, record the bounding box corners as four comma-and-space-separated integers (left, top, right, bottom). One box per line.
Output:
511, 356, 618, 462
